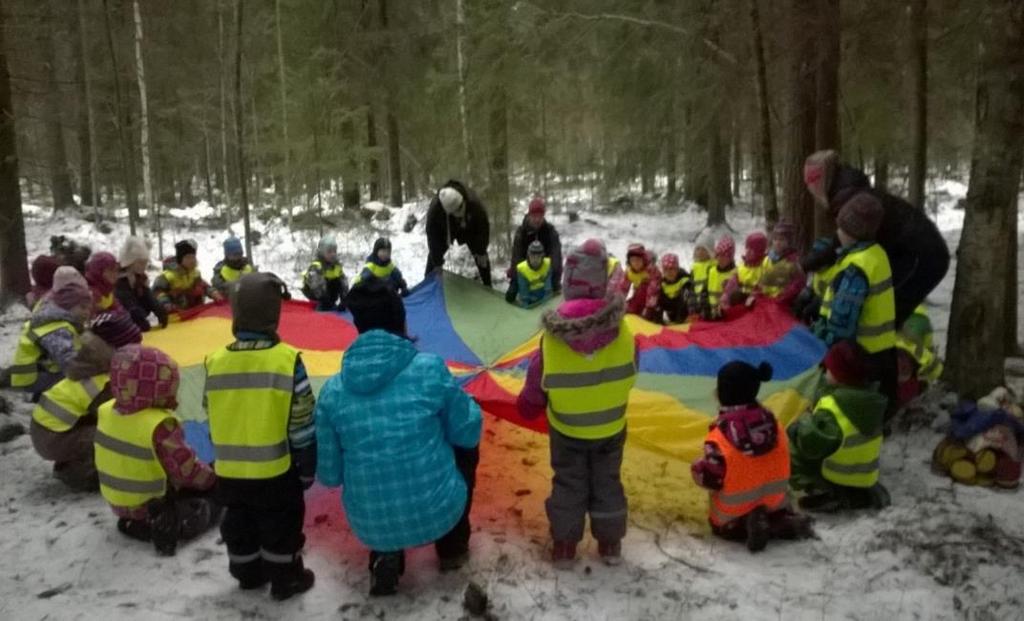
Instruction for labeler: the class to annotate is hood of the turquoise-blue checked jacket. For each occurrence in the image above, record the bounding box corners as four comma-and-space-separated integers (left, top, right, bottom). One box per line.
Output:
341, 330, 418, 395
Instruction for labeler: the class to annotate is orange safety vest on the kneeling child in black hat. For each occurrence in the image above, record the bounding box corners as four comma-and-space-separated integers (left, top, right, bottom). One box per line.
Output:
705, 422, 790, 526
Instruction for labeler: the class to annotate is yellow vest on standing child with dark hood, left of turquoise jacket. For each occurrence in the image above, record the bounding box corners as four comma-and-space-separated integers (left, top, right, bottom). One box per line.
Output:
206, 343, 298, 479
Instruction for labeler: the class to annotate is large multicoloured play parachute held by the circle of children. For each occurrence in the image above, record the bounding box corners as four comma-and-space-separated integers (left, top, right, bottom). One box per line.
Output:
145, 273, 824, 460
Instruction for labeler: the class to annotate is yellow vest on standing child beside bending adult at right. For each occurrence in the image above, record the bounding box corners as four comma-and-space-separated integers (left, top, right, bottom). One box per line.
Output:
821, 244, 896, 354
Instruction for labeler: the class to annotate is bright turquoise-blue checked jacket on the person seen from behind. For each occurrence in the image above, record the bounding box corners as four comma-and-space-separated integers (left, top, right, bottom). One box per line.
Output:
316, 330, 481, 552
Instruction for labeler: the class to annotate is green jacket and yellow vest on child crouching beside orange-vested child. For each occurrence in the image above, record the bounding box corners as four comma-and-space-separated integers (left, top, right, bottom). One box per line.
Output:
788, 386, 886, 492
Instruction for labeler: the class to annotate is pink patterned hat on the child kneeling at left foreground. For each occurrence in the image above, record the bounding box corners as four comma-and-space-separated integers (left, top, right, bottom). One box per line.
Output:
111, 344, 179, 414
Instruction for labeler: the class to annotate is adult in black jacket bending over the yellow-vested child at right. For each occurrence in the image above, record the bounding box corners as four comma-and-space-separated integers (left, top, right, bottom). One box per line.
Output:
801, 151, 949, 328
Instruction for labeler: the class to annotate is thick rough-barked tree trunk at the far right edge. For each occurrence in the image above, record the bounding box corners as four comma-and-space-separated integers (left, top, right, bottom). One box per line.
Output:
946, 0, 1024, 399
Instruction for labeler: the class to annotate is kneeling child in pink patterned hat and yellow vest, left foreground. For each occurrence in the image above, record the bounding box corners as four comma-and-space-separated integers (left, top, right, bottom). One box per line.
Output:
94, 345, 221, 556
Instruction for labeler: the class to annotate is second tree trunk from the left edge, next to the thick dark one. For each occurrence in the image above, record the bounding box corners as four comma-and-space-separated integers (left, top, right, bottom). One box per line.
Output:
40, 0, 75, 209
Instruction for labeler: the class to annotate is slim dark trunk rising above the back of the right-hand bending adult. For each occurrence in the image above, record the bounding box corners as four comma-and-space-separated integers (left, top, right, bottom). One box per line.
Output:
907, 0, 928, 209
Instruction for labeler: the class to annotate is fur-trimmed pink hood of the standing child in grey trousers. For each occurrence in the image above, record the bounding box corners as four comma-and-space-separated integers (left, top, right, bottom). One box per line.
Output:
542, 295, 626, 355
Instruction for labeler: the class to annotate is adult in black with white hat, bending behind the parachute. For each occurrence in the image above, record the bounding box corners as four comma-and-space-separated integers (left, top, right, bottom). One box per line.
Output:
426, 179, 490, 287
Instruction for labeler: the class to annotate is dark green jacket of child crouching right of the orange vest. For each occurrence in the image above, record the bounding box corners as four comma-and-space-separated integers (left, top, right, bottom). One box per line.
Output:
787, 384, 887, 491
